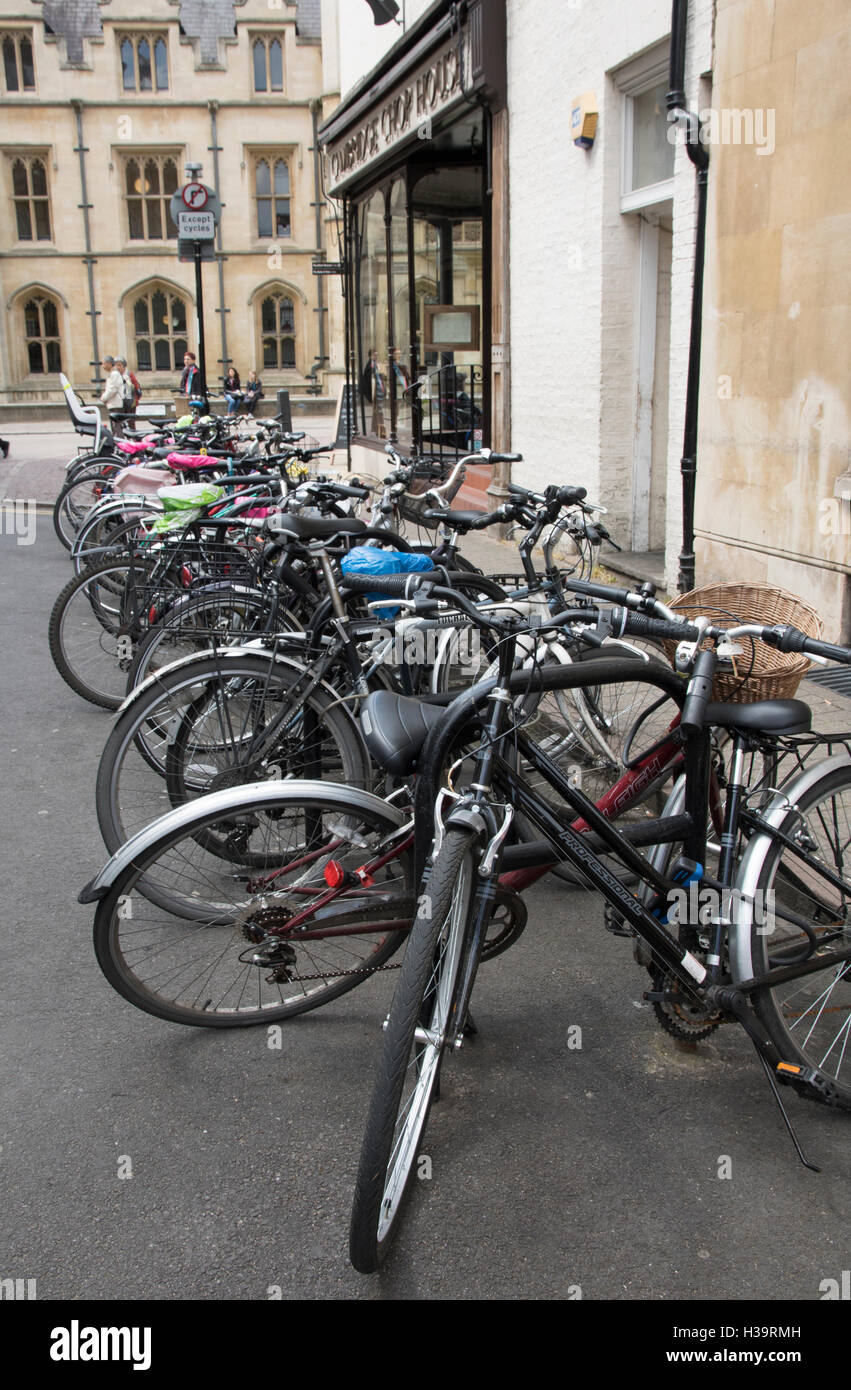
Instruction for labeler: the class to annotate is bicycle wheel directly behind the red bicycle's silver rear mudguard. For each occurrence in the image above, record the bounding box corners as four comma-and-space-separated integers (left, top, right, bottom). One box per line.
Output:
95, 652, 370, 853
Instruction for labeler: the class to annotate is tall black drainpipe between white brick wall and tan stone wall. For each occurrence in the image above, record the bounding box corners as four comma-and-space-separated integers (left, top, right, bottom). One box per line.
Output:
666, 0, 709, 594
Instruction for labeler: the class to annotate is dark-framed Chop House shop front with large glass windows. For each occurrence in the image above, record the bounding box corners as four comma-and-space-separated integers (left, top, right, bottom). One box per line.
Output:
320, 0, 508, 500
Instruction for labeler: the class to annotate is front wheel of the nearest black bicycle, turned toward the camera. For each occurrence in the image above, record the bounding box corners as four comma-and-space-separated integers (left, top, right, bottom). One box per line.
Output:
349, 830, 476, 1275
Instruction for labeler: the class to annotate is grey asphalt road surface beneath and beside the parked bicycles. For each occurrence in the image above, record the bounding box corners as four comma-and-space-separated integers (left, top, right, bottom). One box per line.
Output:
0, 517, 851, 1301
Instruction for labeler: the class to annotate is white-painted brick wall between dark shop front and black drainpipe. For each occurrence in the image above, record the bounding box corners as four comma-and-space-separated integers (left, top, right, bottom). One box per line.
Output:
508, 0, 712, 577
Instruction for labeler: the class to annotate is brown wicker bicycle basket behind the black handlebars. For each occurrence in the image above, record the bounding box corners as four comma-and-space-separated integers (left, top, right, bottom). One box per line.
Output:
663, 584, 825, 705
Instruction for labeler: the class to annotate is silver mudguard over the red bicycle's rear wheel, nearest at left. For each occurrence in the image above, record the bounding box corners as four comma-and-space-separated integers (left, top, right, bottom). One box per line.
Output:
76, 780, 410, 902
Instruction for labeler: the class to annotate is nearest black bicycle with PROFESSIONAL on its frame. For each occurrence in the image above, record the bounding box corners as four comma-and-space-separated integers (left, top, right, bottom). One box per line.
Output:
350, 577, 851, 1272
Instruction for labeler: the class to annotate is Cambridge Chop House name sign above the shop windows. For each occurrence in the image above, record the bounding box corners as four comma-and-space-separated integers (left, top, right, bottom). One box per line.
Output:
328, 40, 470, 193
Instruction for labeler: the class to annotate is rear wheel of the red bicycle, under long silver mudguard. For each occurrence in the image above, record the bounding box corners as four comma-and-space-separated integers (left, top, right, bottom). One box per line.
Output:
93, 783, 414, 1027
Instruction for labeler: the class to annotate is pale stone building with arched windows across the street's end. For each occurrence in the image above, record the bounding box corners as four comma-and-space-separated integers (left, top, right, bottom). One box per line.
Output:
0, 0, 341, 407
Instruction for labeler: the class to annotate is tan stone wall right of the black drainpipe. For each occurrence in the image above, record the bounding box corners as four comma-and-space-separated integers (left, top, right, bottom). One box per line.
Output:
695, 0, 851, 642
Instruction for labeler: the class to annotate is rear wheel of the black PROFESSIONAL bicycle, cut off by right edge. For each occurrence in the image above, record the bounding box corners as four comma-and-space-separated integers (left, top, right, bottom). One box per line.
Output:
749, 766, 851, 1111
